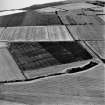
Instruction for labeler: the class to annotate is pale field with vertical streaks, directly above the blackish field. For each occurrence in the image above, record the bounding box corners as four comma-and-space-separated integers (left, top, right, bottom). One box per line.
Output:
0, 25, 73, 41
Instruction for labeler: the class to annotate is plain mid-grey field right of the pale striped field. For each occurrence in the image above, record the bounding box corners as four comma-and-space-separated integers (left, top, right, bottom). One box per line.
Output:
67, 24, 105, 41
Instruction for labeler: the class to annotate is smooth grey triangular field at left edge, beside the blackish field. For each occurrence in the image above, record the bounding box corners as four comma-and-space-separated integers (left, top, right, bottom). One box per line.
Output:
0, 46, 24, 82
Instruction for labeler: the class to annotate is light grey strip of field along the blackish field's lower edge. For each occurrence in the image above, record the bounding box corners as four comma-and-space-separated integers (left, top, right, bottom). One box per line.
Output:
24, 60, 91, 81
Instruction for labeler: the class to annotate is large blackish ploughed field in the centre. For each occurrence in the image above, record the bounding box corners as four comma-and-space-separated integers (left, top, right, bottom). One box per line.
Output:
8, 42, 92, 71
